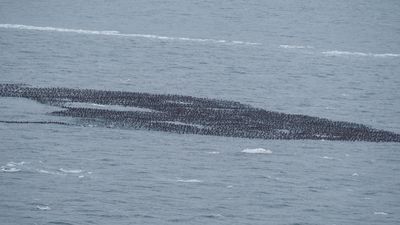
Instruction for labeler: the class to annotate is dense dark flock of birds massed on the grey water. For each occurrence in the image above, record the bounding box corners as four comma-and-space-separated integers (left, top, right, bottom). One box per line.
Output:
0, 84, 400, 142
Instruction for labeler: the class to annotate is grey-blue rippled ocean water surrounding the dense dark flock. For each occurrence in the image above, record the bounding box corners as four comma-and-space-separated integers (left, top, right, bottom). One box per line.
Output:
0, 0, 400, 225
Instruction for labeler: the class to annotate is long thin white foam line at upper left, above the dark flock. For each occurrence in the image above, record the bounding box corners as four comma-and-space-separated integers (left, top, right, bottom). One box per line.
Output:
0, 24, 261, 45
